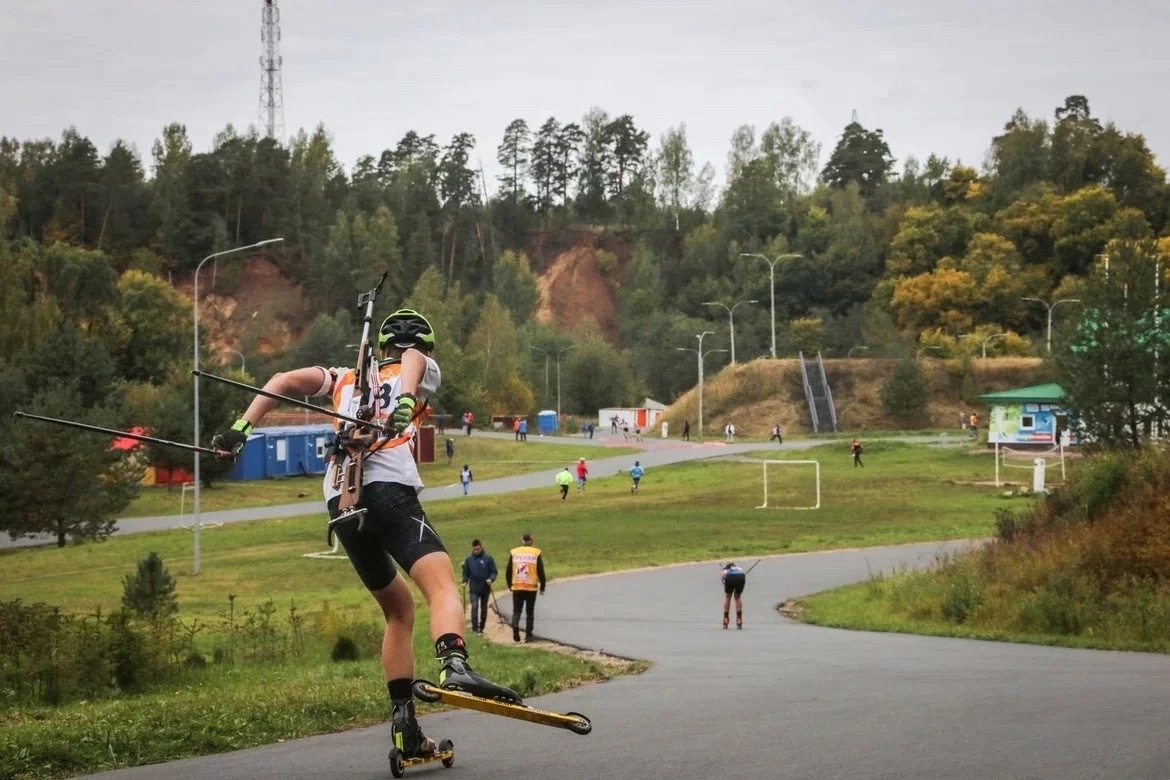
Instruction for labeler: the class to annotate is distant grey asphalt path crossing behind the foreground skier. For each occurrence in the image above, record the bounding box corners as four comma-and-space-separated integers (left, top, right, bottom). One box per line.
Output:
0, 432, 861, 550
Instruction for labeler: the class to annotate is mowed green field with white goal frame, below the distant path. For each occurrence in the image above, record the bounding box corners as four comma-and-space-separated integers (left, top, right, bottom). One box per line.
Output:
0, 442, 1021, 617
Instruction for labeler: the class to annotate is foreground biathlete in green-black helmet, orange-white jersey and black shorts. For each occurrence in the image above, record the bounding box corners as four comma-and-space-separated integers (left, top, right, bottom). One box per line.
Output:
212, 309, 522, 758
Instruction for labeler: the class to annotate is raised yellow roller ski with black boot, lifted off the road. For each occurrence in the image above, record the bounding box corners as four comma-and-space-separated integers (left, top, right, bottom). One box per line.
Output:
411, 656, 593, 734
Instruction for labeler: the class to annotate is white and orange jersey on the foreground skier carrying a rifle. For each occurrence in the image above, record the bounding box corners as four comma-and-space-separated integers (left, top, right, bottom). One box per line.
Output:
322, 357, 442, 502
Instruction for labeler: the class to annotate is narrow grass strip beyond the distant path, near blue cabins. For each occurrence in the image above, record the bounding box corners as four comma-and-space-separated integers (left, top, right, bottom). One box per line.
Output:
119, 435, 641, 517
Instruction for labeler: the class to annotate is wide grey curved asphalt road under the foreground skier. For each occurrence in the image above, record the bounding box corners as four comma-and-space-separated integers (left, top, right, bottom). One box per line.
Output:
84, 544, 1170, 780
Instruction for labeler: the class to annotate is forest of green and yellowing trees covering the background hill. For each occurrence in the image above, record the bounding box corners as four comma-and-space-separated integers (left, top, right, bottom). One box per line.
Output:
0, 96, 1170, 542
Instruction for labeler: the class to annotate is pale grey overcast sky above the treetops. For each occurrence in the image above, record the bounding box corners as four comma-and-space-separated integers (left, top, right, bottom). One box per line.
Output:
0, 0, 1170, 190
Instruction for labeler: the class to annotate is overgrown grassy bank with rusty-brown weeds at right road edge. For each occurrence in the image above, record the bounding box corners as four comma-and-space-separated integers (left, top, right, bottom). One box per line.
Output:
794, 446, 1170, 653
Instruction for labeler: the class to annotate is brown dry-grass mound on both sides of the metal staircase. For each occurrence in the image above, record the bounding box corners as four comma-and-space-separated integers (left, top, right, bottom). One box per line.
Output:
665, 358, 1046, 436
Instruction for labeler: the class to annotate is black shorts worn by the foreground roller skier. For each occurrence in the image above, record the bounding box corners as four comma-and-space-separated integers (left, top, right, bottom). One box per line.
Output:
329, 482, 447, 591
